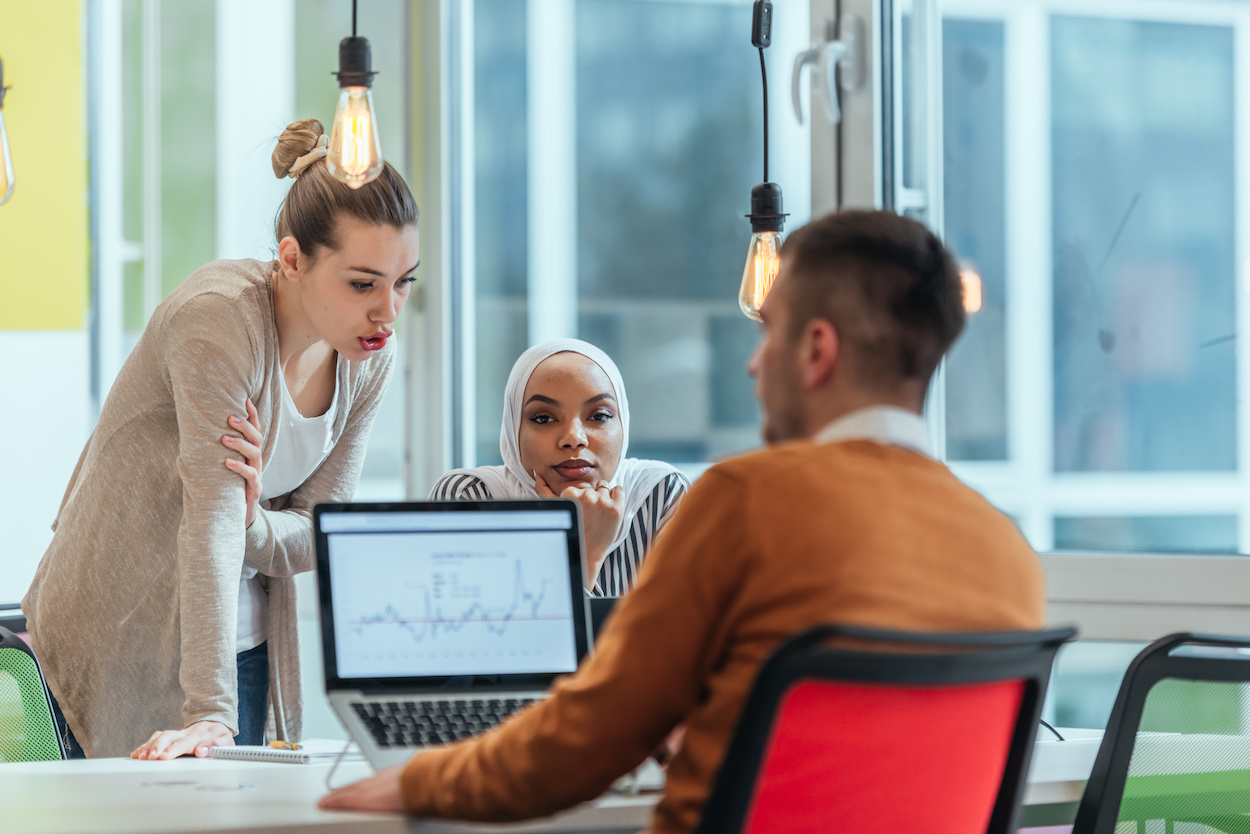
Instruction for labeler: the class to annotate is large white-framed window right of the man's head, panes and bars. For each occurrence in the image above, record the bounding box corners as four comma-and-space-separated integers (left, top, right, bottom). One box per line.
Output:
943, 0, 1250, 553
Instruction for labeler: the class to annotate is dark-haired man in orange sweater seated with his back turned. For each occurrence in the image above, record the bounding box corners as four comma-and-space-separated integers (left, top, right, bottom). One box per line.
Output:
321, 211, 1045, 834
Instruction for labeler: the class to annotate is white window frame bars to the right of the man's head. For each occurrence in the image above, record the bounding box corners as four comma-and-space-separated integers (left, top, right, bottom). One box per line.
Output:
944, 0, 1250, 553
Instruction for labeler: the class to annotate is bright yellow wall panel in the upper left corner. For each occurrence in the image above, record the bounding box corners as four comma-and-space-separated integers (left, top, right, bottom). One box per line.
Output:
0, 0, 90, 330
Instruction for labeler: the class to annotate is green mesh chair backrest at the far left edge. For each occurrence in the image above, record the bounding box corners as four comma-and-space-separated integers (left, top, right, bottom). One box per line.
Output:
0, 628, 65, 761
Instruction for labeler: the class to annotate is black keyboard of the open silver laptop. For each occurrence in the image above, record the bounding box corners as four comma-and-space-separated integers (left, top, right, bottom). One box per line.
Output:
351, 698, 538, 749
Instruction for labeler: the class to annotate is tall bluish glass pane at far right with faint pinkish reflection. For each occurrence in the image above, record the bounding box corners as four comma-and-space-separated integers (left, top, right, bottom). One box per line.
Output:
1051, 16, 1236, 471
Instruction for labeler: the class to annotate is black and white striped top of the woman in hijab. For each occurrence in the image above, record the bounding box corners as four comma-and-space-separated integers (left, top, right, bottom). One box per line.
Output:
430, 471, 690, 596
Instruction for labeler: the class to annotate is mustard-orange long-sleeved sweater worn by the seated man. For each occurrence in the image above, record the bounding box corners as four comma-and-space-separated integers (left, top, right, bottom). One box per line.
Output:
403, 440, 1045, 833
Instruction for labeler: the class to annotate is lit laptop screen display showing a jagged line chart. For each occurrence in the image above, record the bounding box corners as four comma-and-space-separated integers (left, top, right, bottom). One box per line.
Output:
330, 530, 576, 676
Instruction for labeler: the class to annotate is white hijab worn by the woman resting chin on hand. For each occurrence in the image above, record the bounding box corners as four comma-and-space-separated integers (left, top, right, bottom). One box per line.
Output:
448, 339, 678, 553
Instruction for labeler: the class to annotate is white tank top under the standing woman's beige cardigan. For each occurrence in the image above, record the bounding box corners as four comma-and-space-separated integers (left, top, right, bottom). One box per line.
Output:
235, 356, 339, 653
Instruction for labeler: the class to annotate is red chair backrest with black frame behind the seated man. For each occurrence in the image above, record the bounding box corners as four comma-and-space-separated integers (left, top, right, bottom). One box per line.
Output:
699, 626, 1075, 834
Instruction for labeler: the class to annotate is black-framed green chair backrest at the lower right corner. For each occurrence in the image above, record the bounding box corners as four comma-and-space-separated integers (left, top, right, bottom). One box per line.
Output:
1073, 633, 1250, 834
